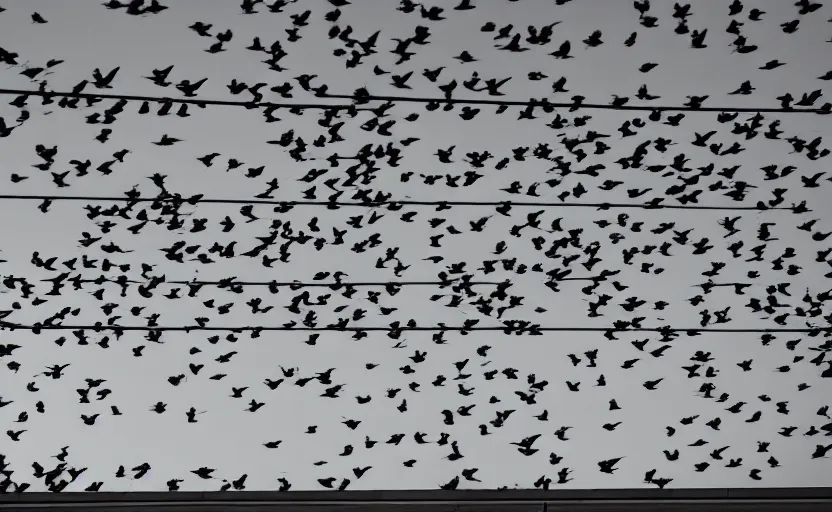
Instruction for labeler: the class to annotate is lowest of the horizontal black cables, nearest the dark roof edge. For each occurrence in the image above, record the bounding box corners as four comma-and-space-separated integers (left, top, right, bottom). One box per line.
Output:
0, 322, 832, 334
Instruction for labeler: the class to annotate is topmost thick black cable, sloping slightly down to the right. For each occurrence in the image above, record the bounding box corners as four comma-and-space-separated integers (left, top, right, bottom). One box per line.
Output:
0, 89, 830, 114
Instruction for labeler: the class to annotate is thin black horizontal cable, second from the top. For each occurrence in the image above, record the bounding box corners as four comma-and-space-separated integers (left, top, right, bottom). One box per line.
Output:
0, 194, 800, 213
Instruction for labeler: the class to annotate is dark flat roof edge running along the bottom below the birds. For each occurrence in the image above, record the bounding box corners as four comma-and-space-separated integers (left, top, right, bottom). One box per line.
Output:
0, 487, 832, 512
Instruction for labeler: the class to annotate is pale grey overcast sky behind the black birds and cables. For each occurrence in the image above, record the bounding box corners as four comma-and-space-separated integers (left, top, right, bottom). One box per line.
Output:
0, 0, 832, 491
